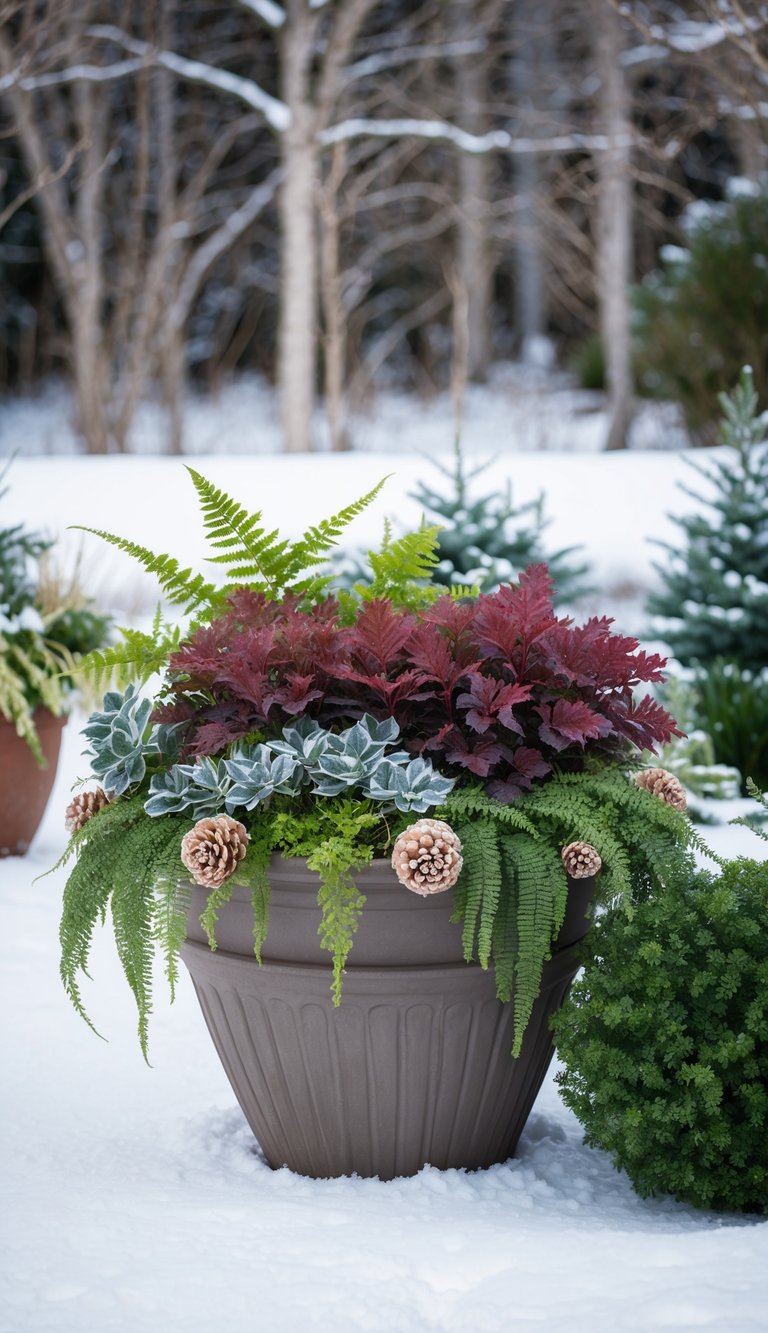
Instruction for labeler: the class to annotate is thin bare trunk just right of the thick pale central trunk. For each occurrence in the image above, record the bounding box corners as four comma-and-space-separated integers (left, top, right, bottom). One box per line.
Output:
320, 144, 348, 449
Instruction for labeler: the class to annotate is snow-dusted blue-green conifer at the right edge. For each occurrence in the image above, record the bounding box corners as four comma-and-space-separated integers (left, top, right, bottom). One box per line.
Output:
648, 368, 768, 670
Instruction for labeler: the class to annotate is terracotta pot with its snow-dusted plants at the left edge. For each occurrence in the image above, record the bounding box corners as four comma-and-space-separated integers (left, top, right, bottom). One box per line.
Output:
0, 458, 108, 856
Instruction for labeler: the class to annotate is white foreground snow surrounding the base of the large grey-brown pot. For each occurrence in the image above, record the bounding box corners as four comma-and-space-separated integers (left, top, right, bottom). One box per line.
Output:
0, 722, 768, 1333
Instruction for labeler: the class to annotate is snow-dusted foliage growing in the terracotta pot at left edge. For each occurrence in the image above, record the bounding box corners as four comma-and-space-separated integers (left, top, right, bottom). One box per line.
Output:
0, 458, 109, 765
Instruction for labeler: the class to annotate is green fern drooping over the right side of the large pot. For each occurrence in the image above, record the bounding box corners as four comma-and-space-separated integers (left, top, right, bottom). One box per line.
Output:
437, 769, 711, 1056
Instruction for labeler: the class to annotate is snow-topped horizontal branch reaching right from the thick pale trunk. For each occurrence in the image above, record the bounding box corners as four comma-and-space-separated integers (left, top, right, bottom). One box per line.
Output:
317, 119, 635, 155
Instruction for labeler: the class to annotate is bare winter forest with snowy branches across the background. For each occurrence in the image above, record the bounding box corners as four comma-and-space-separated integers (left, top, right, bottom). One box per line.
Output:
0, 0, 768, 453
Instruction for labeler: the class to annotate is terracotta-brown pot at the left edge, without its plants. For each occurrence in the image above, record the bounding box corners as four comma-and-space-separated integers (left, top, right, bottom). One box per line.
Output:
0, 708, 67, 856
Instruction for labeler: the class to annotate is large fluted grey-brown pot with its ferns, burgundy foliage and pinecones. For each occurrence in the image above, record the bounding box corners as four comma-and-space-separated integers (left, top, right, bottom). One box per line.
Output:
61, 469, 695, 1178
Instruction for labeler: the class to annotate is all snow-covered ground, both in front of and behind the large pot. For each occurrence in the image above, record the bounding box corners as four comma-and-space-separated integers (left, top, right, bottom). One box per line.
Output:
0, 378, 768, 1333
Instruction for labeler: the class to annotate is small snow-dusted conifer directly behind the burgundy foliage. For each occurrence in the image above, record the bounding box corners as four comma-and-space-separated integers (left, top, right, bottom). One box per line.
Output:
411, 441, 588, 603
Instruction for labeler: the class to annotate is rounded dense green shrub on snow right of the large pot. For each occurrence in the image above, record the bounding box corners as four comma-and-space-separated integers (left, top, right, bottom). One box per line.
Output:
555, 858, 768, 1213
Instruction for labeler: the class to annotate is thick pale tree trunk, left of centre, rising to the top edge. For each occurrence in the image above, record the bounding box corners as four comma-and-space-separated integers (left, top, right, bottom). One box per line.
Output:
277, 0, 317, 453
